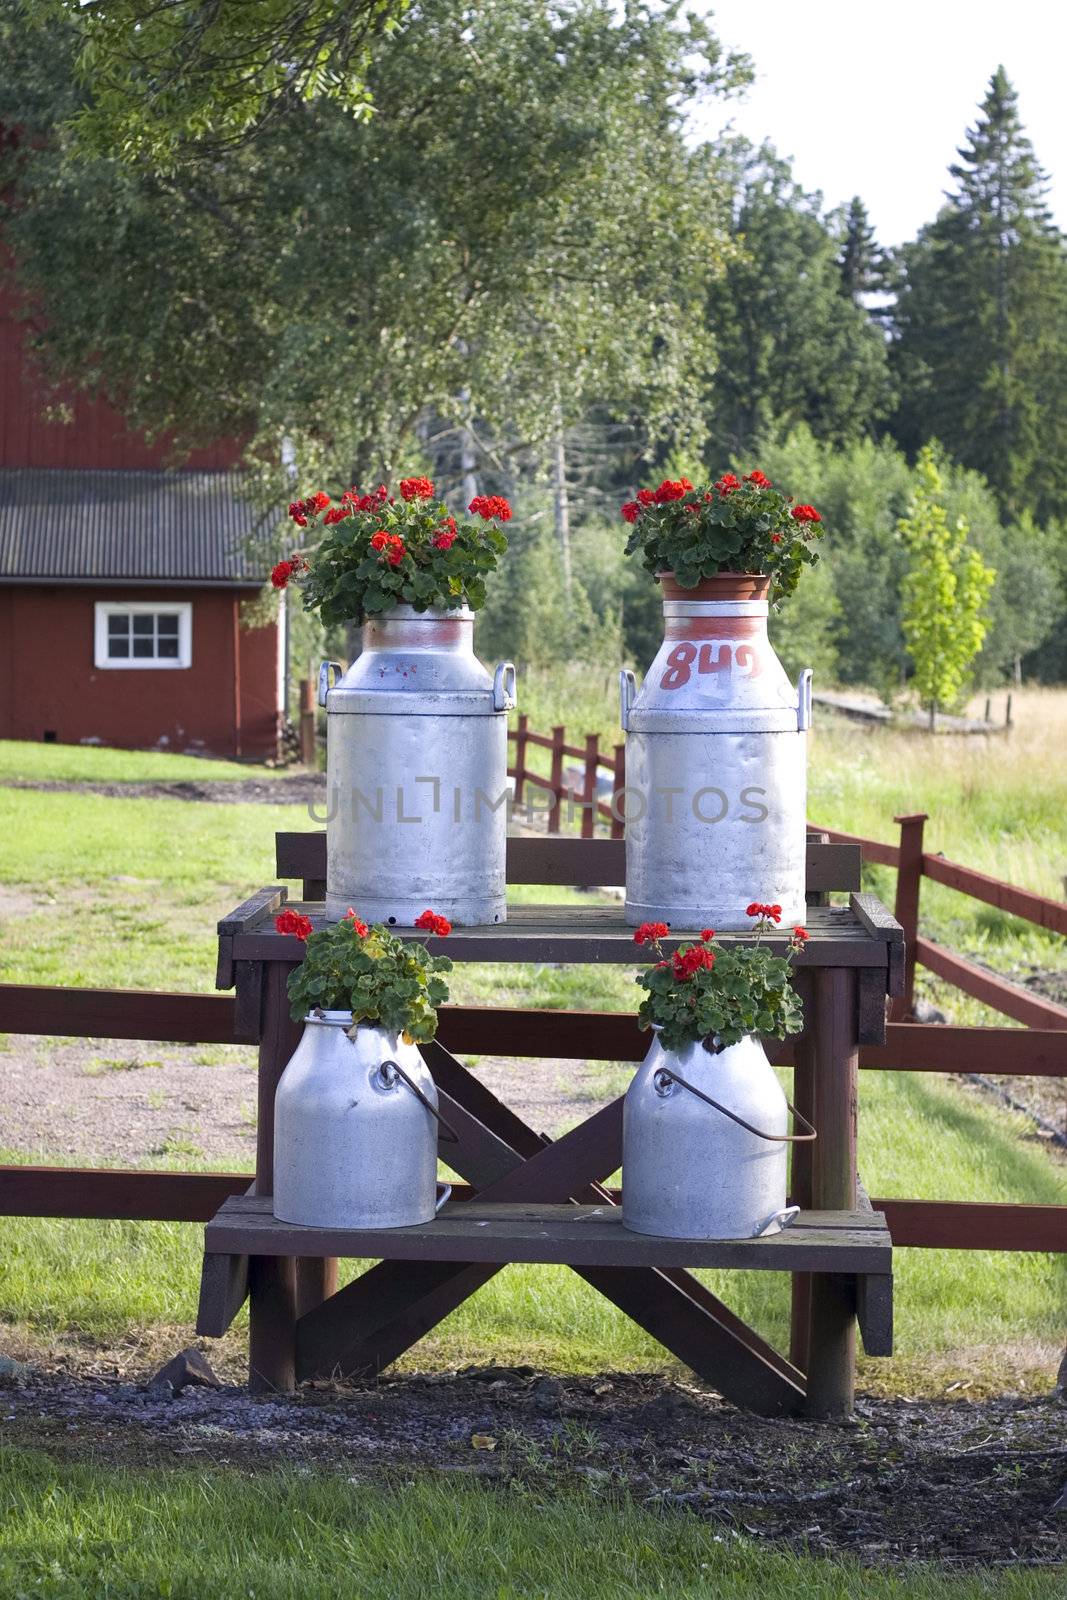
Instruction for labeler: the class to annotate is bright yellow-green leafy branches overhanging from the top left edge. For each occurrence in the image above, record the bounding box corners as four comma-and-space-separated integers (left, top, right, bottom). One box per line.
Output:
33, 0, 408, 171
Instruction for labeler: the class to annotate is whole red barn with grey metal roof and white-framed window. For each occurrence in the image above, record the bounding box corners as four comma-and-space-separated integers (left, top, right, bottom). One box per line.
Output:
0, 278, 285, 760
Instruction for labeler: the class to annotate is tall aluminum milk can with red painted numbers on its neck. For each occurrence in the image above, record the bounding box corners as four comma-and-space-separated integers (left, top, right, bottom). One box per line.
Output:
621, 573, 811, 931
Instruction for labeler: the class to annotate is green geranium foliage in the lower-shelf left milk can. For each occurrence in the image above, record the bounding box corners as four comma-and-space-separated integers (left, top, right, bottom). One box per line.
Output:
290, 917, 453, 1043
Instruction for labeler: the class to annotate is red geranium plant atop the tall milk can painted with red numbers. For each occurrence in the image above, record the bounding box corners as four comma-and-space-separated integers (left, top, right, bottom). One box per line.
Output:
622, 470, 822, 600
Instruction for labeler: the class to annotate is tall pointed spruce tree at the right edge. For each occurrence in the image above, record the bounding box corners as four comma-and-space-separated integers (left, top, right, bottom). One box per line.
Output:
893, 67, 1067, 518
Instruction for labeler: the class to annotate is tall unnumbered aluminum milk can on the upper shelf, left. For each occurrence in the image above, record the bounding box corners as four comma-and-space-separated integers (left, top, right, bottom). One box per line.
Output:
318, 605, 515, 928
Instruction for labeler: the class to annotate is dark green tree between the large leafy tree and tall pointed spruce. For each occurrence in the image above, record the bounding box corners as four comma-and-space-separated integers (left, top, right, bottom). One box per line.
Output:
705, 141, 891, 456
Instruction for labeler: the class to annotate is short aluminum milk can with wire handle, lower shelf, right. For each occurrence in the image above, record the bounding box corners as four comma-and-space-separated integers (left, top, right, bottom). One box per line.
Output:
622, 1037, 814, 1238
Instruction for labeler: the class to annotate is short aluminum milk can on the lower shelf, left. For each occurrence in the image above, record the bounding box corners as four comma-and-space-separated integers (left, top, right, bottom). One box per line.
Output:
274, 1011, 451, 1227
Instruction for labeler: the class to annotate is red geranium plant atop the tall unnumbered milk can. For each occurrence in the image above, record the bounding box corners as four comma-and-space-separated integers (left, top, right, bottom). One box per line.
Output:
290, 478, 510, 626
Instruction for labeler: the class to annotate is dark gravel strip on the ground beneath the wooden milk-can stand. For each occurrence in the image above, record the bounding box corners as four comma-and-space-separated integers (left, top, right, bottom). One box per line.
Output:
0, 1363, 1067, 1570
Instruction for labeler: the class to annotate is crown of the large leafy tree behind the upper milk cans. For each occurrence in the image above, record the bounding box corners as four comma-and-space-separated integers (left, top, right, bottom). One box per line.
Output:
0, 0, 747, 493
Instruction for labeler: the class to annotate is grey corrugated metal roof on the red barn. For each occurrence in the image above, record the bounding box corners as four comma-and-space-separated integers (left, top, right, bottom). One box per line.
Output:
0, 467, 270, 584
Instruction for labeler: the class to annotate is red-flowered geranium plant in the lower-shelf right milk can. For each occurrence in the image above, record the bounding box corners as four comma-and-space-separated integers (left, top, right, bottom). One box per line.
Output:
635, 922, 805, 1051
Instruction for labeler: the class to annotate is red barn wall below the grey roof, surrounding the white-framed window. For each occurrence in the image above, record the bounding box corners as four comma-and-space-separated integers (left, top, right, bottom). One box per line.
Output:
0, 584, 278, 760
